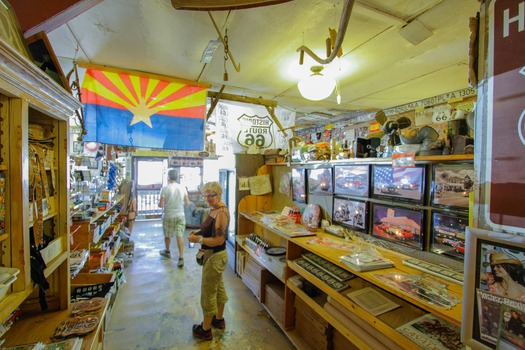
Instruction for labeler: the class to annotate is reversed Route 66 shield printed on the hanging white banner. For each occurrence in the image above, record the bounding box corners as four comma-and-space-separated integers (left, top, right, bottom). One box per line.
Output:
237, 114, 273, 148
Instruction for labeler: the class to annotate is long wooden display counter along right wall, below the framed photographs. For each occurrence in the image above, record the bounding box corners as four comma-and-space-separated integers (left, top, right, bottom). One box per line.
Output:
237, 213, 463, 349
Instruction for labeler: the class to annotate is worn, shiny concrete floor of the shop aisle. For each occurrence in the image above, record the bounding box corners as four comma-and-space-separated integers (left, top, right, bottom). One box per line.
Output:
105, 220, 294, 350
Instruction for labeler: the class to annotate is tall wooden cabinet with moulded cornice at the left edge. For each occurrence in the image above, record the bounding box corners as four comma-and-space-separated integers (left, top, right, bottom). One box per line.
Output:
0, 36, 81, 344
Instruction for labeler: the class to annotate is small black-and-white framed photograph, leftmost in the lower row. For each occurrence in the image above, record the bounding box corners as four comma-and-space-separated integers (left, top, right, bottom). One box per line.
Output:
332, 197, 368, 232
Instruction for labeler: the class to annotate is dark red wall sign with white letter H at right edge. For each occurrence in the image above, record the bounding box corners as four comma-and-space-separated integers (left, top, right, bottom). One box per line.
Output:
486, 0, 525, 231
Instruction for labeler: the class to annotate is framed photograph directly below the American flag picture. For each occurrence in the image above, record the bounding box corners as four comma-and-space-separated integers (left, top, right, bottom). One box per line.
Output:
372, 203, 425, 250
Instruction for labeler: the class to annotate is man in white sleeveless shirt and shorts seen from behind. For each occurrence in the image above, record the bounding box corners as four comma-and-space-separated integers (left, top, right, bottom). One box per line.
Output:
159, 169, 190, 267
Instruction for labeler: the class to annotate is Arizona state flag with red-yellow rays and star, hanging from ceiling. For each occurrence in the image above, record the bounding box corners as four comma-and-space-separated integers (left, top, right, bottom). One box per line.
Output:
81, 69, 207, 150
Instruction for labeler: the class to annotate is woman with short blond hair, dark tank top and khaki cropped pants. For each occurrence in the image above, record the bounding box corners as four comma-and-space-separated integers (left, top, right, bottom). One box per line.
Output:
188, 182, 230, 340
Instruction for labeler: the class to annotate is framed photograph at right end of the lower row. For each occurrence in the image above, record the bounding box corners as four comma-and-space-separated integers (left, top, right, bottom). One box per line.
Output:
430, 211, 468, 260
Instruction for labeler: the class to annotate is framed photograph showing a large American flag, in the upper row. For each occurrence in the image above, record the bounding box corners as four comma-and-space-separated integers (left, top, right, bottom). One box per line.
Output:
372, 164, 425, 204
